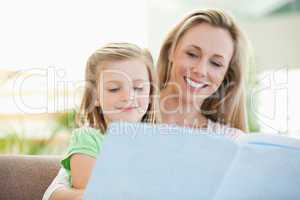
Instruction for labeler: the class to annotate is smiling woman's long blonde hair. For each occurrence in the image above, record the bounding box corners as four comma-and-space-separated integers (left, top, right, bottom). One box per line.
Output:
157, 9, 248, 131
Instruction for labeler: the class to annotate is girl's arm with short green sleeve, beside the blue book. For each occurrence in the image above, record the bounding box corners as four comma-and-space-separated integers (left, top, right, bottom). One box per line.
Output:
43, 127, 103, 200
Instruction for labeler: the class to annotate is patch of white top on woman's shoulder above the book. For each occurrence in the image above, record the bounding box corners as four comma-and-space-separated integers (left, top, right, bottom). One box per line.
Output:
207, 119, 245, 139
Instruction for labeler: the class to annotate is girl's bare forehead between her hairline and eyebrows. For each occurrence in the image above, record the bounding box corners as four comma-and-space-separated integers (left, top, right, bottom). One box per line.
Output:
100, 59, 149, 80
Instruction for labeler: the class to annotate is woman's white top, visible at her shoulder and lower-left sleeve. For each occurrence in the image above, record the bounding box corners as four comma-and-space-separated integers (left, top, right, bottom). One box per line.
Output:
42, 120, 244, 200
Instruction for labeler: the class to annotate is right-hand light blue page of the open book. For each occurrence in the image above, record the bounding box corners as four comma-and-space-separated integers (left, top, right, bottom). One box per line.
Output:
214, 143, 300, 200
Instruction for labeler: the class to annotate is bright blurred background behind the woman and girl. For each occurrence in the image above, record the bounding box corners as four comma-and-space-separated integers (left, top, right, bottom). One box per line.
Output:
0, 0, 300, 154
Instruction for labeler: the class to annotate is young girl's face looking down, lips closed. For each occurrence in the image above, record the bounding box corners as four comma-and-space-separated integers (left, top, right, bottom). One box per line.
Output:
99, 59, 150, 122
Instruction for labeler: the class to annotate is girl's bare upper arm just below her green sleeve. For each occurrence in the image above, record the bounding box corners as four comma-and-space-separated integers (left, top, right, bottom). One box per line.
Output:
70, 154, 96, 189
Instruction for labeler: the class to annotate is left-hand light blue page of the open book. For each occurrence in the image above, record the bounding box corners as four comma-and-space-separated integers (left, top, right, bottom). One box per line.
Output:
84, 123, 238, 200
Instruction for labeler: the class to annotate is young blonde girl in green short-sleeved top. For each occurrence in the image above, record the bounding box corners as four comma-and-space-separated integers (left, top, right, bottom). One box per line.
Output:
43, 43, 158, 199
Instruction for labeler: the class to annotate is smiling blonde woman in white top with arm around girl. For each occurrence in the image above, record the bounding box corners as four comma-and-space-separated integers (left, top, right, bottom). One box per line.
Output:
43, 10, 252, 200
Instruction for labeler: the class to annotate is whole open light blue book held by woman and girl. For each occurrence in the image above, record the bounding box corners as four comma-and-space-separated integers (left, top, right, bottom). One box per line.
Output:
84, 122, 300, 200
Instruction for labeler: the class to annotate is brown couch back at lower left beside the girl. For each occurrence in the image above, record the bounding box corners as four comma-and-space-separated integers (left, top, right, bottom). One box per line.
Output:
0, 155, 60, 200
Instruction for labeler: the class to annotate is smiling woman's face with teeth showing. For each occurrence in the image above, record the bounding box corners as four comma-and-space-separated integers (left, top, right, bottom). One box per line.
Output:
169, 23, 234, 105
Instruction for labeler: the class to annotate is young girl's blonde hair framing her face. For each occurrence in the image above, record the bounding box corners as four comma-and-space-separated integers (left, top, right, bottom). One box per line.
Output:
76, 43, 158, 134
